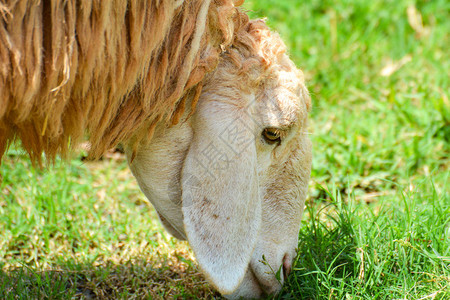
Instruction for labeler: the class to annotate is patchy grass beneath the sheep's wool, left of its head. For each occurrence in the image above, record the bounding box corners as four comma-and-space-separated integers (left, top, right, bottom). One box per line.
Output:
0, 154, 218, 299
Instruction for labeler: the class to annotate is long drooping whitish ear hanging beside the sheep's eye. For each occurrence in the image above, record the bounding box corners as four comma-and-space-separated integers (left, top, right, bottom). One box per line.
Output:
182, 102, 261, 294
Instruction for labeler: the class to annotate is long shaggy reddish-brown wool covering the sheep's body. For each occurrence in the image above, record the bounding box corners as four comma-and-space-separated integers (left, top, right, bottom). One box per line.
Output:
0, 0, 248, 163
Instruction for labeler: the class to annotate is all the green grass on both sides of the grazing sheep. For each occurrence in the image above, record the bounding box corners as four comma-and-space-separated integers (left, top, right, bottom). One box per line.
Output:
0, 0, 450, 299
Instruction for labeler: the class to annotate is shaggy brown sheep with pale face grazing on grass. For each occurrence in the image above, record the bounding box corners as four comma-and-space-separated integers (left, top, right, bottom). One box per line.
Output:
0, 0, 312, 299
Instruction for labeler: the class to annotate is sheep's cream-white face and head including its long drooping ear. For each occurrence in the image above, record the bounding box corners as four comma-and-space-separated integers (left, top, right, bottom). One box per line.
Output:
128, 50, 311, 298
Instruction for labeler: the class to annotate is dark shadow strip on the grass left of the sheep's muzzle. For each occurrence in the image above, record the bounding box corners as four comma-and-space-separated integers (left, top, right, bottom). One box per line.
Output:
0, 258, 220, 299
